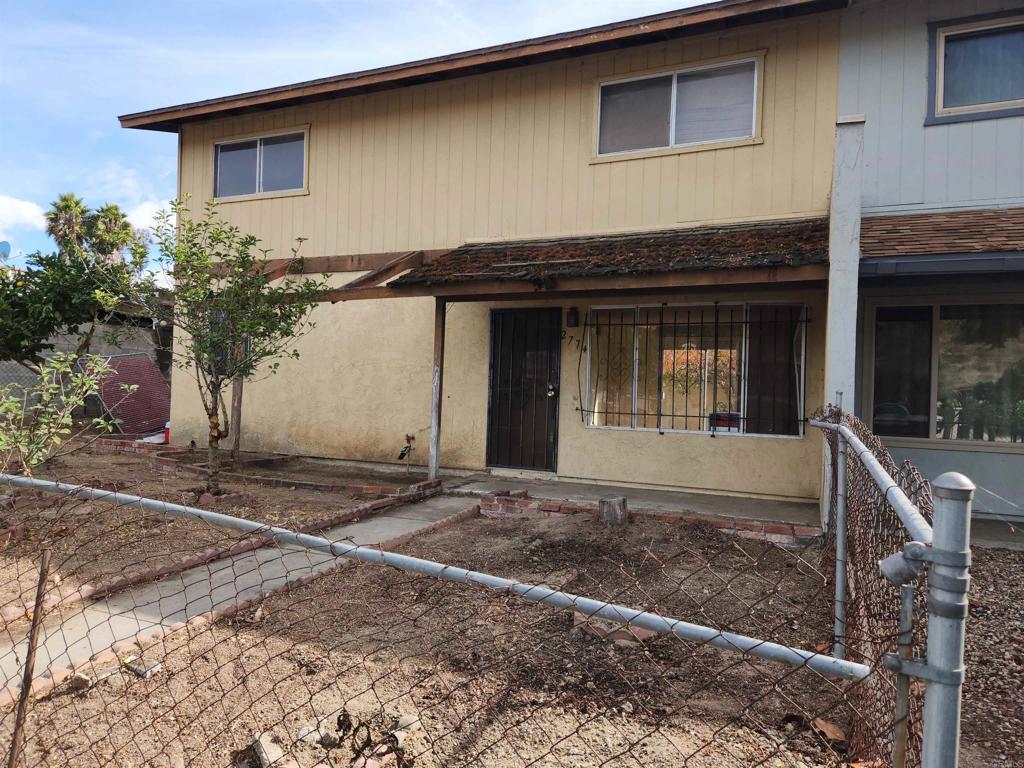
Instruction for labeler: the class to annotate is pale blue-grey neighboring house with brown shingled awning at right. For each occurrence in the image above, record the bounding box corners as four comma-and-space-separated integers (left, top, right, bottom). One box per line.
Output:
839, 0, 1024, 518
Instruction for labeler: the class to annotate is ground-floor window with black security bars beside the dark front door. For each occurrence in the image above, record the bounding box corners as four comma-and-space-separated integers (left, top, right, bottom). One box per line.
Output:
584, 304, 807, 435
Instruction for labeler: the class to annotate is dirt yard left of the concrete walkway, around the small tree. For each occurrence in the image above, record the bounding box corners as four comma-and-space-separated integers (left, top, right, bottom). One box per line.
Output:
0, 450, 358, 610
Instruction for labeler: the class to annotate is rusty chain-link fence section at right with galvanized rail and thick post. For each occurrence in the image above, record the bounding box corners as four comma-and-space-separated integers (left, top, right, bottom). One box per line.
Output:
810, 408, 975, 768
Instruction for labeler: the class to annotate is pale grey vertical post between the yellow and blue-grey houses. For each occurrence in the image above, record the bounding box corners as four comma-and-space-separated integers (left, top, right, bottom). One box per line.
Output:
824, 115, 864, 411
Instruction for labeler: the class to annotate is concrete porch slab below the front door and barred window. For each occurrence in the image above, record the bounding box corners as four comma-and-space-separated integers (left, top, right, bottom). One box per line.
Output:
444, 475, 820, 526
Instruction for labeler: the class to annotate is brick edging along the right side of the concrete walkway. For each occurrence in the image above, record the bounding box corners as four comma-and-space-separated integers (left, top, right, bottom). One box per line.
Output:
0, 504, 480, 709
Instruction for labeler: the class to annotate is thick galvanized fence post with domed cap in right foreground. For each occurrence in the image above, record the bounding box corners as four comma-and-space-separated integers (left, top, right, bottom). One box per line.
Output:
922, 472, 975, 768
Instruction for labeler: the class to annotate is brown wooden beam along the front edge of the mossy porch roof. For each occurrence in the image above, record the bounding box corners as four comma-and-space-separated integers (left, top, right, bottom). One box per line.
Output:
321, 264, 828, 302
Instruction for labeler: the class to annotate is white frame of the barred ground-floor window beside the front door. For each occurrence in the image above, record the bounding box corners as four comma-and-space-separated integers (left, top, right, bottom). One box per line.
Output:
581, 300, 807, 440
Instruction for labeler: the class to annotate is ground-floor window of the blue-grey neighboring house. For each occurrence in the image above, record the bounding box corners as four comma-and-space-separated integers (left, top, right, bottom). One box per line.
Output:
871, 303, 1024, 442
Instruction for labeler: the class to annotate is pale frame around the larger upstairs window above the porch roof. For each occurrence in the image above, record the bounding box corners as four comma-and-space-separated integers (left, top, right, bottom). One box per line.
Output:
594, 56, 764, 160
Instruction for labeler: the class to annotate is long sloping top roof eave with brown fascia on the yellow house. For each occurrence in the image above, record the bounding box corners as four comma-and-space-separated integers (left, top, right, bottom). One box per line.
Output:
119, 0, 848, 132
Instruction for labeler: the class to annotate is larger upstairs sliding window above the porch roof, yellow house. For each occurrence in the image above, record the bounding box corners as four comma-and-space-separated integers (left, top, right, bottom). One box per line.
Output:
597, 57, 760, 156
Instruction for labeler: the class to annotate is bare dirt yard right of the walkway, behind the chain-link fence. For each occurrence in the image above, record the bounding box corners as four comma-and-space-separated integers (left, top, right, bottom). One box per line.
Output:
14, 514, 853, 768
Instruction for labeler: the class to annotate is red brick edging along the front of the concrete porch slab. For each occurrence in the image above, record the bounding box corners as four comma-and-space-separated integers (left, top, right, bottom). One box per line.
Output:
480, 490, 822, 547
